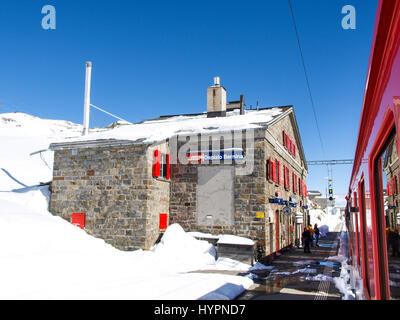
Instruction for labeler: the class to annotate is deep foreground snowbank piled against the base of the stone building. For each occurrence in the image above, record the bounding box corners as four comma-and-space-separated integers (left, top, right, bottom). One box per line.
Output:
0, 187, 253, 300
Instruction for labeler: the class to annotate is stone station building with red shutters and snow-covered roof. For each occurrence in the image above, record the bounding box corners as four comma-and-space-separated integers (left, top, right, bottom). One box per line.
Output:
50, 79, 307, 256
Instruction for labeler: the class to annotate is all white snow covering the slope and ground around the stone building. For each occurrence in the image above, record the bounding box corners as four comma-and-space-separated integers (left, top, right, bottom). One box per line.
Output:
0, 113, 351, 300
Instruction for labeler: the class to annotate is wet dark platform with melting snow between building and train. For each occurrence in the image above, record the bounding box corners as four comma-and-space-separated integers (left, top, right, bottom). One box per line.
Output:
237, 228, 342, 300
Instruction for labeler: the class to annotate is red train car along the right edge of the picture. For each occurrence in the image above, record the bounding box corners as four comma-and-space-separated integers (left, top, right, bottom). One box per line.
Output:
345, 0, 400, 300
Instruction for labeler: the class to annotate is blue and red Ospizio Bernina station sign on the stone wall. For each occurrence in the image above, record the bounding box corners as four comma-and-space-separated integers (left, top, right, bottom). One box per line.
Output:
186, 148, 244, 163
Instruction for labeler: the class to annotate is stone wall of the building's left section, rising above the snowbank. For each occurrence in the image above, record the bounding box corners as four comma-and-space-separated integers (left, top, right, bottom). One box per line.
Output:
50, 145, 169, 250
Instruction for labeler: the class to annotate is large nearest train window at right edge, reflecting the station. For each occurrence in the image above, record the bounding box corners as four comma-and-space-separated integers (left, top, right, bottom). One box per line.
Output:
376, 134, 400, 299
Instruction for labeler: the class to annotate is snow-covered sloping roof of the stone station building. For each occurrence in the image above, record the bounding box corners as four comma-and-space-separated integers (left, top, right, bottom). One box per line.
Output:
51, 107, 291, 149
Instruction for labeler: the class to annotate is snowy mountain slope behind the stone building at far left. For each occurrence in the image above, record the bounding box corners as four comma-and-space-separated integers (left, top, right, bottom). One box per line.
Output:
0, 112, 82, 191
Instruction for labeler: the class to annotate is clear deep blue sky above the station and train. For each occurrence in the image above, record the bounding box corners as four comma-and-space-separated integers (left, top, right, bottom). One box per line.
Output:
0, 0, 377, 204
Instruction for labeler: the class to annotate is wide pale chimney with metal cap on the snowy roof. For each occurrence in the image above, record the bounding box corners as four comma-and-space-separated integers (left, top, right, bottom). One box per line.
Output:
207, 77, 226, 118
